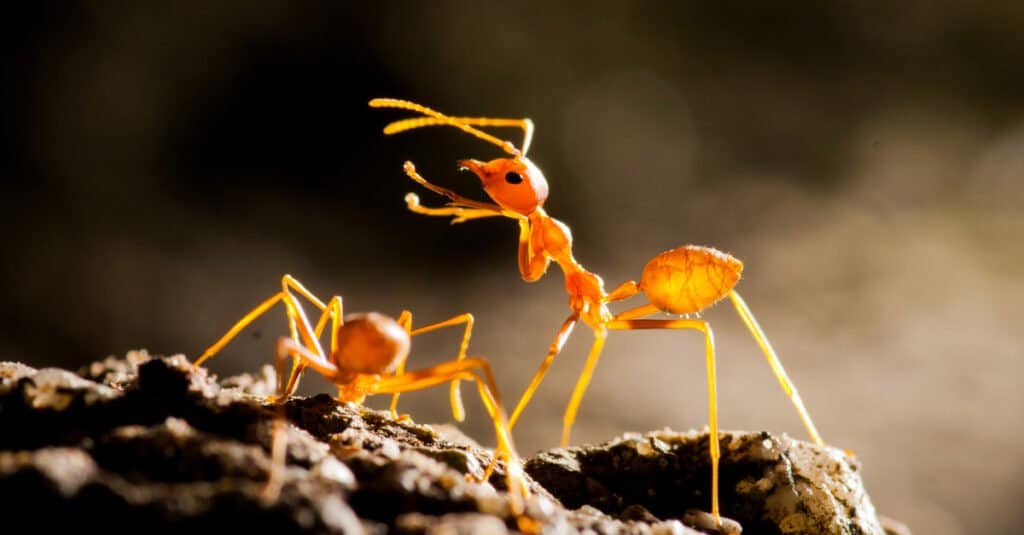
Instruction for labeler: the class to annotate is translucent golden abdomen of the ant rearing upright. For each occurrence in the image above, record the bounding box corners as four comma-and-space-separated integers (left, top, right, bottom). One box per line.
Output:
640, 245, 743, 314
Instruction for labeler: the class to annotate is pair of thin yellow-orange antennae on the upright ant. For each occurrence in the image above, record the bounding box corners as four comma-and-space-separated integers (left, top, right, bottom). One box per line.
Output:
370, 98, 534, 158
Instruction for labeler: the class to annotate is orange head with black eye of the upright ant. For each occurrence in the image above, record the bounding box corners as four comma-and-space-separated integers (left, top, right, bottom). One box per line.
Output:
459, 156, 548, 215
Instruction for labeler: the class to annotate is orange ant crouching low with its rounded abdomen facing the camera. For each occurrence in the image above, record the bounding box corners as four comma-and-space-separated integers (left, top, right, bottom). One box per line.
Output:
195, 275, 529, 514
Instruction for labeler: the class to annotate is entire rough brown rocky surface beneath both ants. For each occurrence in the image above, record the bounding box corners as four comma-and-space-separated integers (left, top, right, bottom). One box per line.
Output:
0, 352, 901, 535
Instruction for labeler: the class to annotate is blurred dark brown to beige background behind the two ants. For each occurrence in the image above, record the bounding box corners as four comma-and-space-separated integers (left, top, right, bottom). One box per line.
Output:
0, 0, 1024, 534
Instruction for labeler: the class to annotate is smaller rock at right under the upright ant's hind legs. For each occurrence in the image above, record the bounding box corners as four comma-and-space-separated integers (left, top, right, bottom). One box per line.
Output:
526, 430, 885, 535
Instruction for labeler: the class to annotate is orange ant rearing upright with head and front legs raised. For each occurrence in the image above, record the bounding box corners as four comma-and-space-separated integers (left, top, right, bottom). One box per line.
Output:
370, 98, 824, 528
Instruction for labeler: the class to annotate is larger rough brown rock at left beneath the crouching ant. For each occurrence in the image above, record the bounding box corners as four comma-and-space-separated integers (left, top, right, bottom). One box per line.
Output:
0, 352, 516, 534
